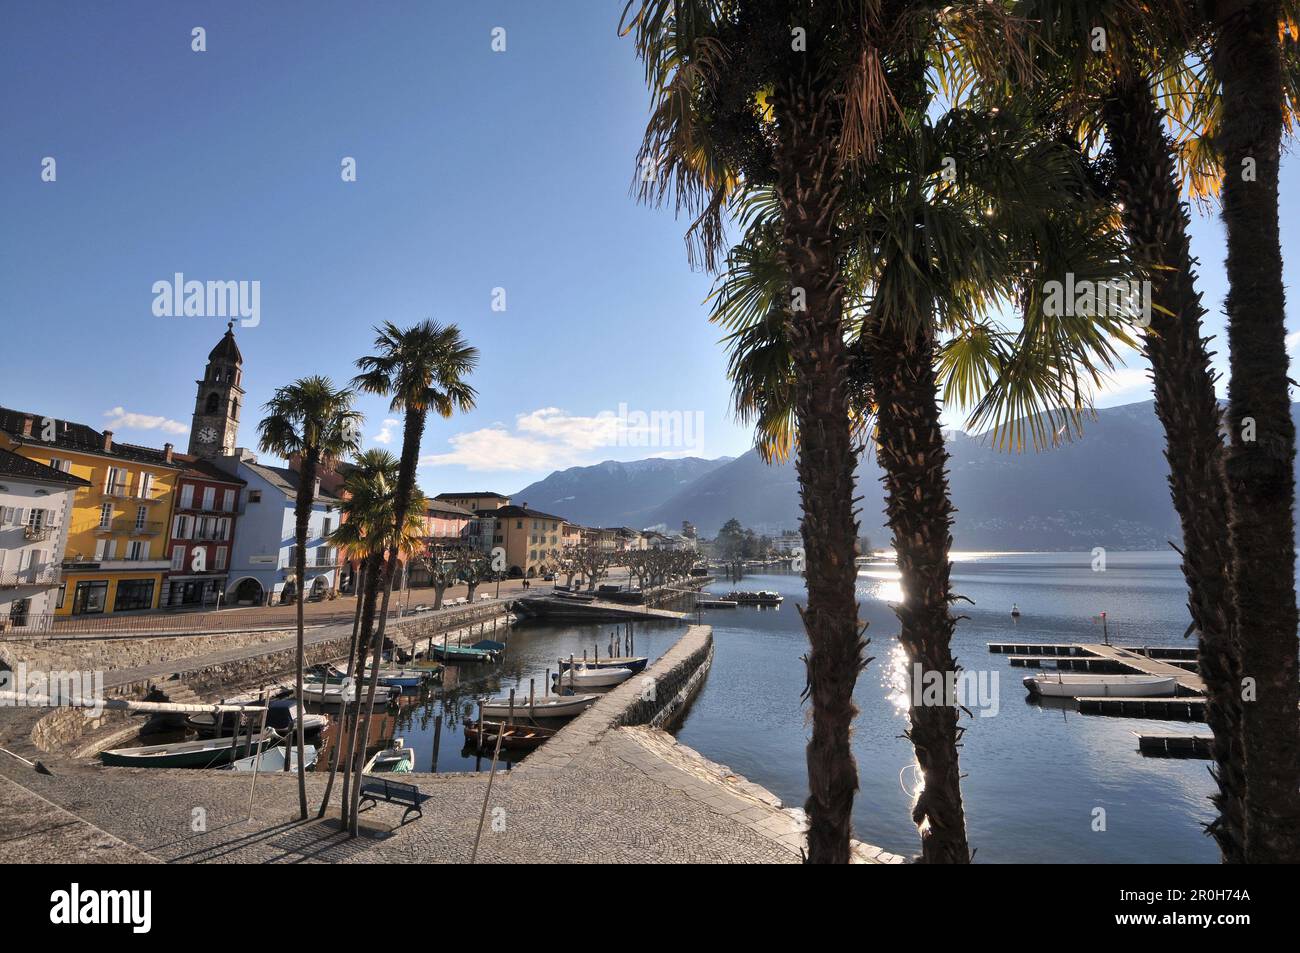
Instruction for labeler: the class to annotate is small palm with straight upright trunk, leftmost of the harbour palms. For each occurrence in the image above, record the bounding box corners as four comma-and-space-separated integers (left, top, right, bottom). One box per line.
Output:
257, 377, 363, 820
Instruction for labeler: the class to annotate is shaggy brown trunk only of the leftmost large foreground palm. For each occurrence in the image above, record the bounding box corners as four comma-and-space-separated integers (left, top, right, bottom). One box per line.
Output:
774, 74, 866, 863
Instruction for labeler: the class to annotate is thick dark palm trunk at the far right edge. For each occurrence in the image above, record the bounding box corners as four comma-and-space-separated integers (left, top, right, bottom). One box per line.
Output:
1213, 0, 1300, 863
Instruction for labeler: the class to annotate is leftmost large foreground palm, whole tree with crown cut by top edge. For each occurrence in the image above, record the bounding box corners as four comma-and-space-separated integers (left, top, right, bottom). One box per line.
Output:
624, 0, 1040, 863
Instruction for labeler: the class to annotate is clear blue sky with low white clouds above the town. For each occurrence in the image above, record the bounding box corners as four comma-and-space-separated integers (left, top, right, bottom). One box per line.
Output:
0, 0, 1297, 493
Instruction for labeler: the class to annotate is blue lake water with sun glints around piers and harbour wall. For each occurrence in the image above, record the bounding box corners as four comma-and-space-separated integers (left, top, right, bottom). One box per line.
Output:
332, 553, 1218, 863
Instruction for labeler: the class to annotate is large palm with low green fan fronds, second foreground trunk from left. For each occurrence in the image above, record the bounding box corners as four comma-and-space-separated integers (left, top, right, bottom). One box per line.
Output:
714, 91, 1126, 862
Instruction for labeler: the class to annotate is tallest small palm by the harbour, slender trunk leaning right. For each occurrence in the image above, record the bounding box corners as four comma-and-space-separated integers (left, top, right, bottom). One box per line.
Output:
350, 321, 478, 835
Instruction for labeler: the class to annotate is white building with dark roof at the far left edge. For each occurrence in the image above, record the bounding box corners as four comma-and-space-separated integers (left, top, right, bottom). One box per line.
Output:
0, 450, 90, 632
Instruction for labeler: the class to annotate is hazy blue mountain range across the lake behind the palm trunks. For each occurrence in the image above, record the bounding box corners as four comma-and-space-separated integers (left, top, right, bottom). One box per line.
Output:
514, 400, 1300, 551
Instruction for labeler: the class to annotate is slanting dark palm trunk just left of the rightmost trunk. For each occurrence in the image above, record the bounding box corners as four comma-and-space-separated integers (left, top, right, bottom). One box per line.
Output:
1104, 65, 1245, 863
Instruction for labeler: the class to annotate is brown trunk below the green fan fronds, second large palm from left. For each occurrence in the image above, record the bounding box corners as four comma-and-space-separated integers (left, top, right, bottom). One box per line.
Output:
868, 315, 971, 863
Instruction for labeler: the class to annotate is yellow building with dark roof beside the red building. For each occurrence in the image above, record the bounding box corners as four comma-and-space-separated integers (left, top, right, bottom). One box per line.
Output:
0, 407, 185, 616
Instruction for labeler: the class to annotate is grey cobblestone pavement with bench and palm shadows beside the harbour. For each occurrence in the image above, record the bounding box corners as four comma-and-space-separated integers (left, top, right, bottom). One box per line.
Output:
0, 627, 902, 863
